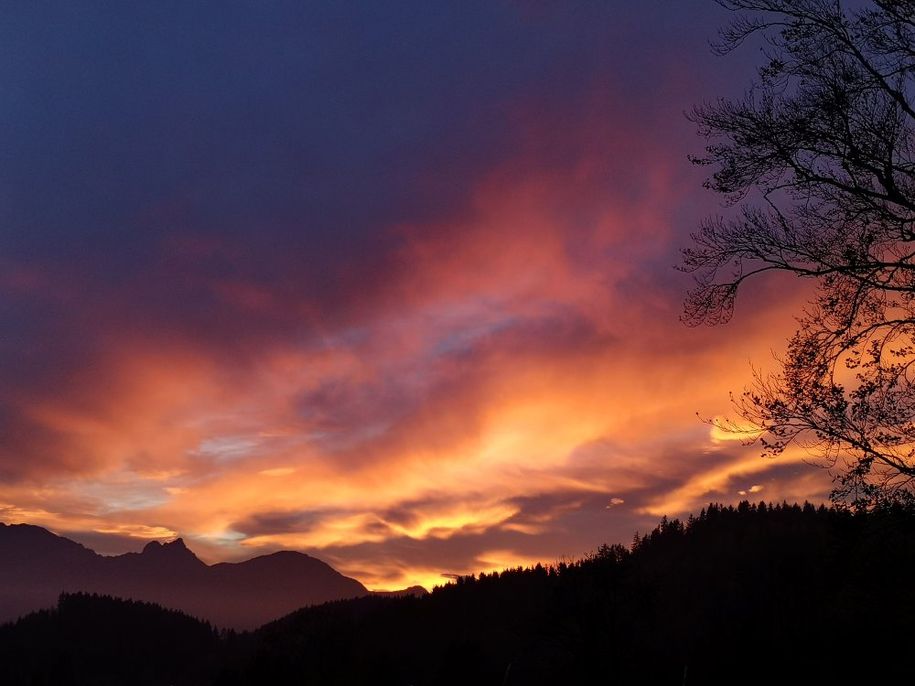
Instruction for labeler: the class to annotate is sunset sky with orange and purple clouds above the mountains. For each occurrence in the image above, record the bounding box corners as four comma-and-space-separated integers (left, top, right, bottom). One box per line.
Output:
0, 0, 830, 589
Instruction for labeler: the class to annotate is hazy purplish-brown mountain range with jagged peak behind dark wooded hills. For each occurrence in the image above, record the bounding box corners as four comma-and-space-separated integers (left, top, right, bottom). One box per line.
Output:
0, 524, 369, 629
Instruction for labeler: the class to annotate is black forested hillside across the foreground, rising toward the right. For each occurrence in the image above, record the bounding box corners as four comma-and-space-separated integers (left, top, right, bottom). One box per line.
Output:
0, 503, 915, 686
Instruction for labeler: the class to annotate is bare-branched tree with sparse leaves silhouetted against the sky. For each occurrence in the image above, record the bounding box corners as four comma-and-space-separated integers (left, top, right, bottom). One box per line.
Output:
680, 0, 915, 506
